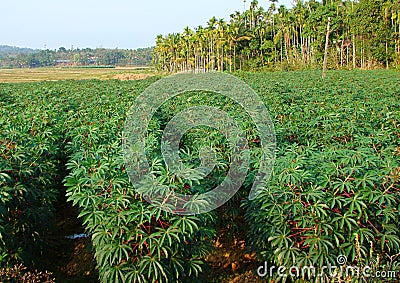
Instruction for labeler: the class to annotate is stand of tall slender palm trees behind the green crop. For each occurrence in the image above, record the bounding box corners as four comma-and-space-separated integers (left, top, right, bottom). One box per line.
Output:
154, 0, 400, 72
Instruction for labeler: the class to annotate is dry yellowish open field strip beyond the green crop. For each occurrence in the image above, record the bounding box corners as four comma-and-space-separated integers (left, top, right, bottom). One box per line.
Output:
0, 67, 149, 82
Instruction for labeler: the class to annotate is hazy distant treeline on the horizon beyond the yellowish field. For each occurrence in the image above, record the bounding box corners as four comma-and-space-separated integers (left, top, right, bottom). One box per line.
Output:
0, 46, 153, 68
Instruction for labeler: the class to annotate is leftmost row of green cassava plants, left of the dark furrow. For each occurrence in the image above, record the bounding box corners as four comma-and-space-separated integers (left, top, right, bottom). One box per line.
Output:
0, 85, 68, 265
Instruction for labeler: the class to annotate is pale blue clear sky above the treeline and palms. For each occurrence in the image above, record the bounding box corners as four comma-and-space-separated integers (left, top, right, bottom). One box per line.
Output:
0, 0, 292, 49
